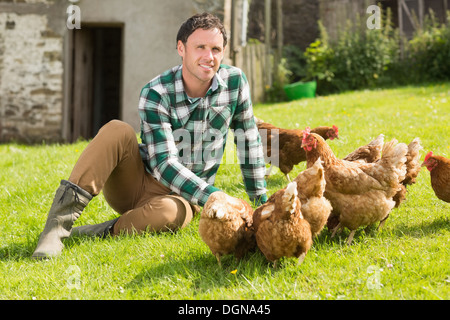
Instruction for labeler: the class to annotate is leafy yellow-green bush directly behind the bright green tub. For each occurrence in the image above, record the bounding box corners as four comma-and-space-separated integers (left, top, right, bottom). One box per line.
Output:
305, 12, 399, 94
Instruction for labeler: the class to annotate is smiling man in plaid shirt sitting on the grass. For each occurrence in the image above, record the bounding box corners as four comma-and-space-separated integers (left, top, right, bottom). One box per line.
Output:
33, 13, 267, 259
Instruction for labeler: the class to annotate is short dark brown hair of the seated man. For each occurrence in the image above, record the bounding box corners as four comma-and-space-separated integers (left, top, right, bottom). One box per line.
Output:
177, 12, 227, 47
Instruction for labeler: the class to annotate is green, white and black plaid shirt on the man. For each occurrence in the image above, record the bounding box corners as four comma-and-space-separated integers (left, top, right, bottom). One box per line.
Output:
139, 65, 267, 206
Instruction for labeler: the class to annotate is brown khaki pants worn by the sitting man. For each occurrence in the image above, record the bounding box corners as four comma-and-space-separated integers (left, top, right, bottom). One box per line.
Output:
69, 120, 194, 235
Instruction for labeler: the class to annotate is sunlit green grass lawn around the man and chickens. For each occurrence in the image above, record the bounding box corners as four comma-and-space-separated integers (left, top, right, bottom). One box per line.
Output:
0, 83, 450, 300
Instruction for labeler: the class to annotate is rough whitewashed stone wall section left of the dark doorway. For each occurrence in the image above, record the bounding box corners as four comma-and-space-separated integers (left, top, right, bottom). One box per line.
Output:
0, 0, 67, 143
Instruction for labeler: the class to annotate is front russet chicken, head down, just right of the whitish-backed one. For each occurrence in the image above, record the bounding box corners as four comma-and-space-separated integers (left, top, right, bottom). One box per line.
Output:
253, 181, 312, 267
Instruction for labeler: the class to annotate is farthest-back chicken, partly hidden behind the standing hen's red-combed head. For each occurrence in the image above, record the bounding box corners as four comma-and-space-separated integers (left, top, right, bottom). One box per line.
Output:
255, 118, 339, 182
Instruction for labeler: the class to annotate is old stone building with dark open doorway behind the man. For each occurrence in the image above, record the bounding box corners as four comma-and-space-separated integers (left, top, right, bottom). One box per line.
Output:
0, 0, 223, 143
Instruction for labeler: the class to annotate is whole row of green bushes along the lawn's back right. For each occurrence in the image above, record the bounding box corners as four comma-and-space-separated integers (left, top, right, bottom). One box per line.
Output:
298, 10, 450, 94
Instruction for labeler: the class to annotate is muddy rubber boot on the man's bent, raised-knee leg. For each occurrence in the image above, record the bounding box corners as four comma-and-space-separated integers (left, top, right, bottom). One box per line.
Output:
31, 180, 92, 259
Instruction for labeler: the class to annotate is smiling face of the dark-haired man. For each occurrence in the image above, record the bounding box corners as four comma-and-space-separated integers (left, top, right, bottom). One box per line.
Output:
177, 28, 224, 86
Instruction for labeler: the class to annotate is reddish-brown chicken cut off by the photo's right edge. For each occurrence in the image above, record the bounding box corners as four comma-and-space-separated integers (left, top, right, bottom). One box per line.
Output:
422, 151, 450, 202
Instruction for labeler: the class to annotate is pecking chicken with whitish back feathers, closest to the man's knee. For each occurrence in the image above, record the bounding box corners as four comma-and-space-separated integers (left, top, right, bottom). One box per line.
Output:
198, 191, 256, 266
